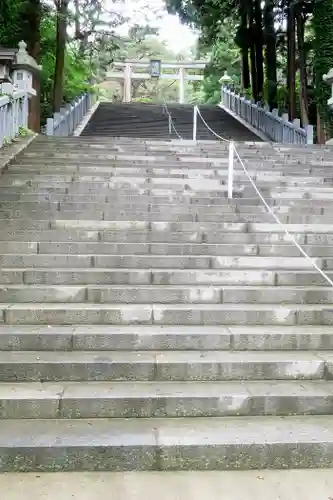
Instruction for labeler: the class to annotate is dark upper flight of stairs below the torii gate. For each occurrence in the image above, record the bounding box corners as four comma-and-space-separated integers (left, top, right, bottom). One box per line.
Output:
82, 102, 259, 141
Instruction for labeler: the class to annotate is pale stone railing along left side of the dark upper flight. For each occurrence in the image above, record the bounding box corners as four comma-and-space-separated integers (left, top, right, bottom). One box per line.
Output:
45, 93, 95, 137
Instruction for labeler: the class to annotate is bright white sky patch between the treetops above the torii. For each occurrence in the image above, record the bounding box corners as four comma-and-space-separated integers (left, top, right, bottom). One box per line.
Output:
114, 0, 196, 52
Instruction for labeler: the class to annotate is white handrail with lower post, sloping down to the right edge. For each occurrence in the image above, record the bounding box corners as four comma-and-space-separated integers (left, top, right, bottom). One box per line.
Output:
195, 109, 333, 287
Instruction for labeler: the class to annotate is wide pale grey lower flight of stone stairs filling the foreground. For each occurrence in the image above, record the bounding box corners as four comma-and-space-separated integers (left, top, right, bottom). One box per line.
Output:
0, 137, 333, 471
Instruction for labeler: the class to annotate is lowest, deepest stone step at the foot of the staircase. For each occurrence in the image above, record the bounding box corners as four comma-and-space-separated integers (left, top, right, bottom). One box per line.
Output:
0, 416, 333, 472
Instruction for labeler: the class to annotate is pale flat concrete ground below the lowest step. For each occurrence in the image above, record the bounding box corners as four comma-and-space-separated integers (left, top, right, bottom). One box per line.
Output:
0, 469, 333, 500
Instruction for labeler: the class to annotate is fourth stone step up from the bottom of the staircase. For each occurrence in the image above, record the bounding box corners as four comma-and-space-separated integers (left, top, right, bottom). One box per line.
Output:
0, 324, 333, 352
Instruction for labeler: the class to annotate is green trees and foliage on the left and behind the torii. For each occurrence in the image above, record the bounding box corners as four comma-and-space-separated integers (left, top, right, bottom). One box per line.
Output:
0, 0, 195, 130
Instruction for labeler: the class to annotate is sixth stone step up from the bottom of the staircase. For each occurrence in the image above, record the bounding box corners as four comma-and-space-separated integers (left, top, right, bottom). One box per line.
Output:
0, 285, 333, 304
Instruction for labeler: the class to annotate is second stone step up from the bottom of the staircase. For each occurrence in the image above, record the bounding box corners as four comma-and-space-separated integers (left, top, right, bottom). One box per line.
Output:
0, 380, 333, 419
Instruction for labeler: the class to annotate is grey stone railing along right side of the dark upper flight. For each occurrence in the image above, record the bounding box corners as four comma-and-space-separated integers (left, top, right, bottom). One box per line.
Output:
221, 86, 313, 144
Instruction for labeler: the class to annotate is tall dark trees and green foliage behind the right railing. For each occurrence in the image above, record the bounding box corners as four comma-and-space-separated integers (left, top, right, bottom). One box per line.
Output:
166, 0, 333, 142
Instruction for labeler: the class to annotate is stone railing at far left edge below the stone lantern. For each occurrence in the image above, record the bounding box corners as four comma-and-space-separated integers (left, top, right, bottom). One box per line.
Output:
0, 90, 29, 148
